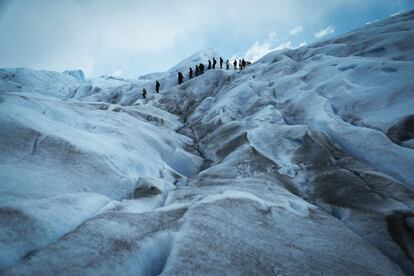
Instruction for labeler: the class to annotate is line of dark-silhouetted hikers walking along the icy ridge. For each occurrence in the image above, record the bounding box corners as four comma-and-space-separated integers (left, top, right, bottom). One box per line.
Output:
142, 57, 251, 99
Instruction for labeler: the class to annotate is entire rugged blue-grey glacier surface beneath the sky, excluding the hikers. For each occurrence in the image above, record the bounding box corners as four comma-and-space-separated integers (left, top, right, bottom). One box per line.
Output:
0, 9, 414, 275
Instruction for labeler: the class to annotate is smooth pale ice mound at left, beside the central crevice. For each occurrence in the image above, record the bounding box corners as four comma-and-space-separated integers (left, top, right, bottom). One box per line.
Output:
0, 92, 201, 266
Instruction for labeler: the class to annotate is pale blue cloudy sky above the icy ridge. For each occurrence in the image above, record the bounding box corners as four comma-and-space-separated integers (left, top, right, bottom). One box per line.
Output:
0, 0, 414, 78
